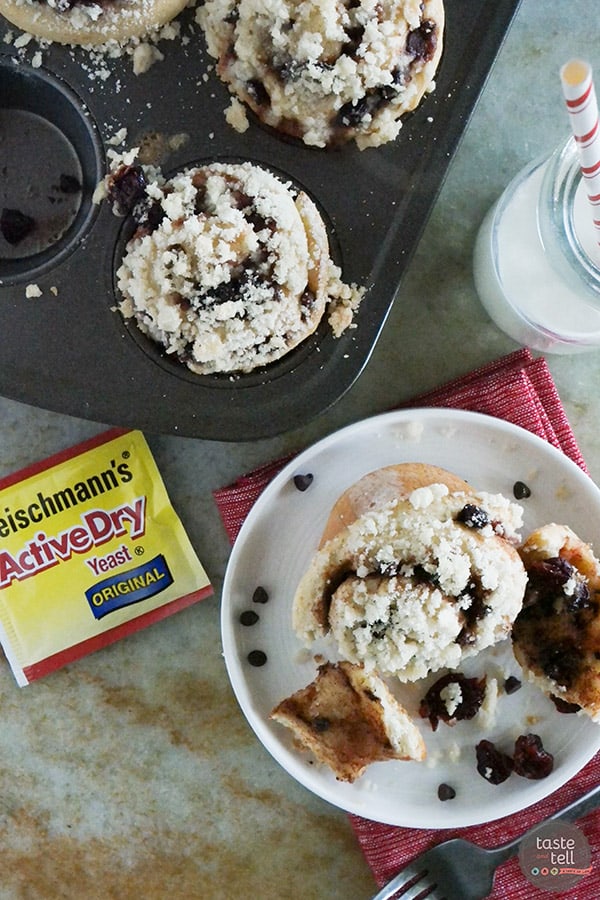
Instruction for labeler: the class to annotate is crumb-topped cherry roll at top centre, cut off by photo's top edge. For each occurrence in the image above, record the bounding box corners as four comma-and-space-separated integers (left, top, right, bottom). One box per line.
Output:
197, 0, 444, 149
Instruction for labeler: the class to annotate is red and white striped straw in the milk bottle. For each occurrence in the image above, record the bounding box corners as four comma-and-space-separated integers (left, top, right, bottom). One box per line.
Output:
560, 59, 600, 243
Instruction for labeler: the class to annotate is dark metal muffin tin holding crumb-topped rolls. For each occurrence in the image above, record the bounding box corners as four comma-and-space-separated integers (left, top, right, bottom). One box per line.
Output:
0, 0, 519, 441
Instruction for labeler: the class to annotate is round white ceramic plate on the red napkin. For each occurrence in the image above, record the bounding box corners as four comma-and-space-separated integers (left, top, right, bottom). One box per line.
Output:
221, 409, 600, 828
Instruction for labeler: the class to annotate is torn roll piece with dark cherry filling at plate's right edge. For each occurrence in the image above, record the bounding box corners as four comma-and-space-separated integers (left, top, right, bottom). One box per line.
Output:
512, 523, 600, 721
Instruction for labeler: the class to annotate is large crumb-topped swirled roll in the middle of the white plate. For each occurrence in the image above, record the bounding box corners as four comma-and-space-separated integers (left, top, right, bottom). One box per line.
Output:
293, 464, 526, 681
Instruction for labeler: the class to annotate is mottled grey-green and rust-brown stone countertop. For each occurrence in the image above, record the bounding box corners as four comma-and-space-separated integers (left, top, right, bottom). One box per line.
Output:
0, 0, 600, 900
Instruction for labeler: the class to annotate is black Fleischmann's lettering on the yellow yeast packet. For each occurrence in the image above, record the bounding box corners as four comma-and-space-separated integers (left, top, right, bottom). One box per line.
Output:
0, 459, 133, 538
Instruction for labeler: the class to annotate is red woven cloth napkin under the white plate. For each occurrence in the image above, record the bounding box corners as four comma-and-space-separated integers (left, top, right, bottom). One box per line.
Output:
214, 349, 600, 900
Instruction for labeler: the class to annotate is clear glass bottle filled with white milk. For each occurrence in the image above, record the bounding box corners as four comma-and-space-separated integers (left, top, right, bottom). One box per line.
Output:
473, 137, 600, 353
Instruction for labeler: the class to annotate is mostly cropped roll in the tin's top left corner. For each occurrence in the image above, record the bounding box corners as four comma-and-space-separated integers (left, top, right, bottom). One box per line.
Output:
0, 0, 187, 45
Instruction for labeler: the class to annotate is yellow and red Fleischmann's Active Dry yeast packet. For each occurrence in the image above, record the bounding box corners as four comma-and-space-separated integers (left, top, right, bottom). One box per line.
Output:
0, 429, 213, 686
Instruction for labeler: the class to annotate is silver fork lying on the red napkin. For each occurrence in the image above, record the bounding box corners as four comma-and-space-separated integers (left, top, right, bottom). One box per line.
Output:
372, 784, 600, 900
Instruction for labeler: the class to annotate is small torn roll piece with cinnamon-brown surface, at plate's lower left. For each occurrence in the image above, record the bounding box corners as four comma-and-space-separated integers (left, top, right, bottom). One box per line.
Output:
271, 662, 425, 782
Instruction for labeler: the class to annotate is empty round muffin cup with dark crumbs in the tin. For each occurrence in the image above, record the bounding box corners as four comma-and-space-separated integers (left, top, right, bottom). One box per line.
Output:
0, 58, 103, 283
